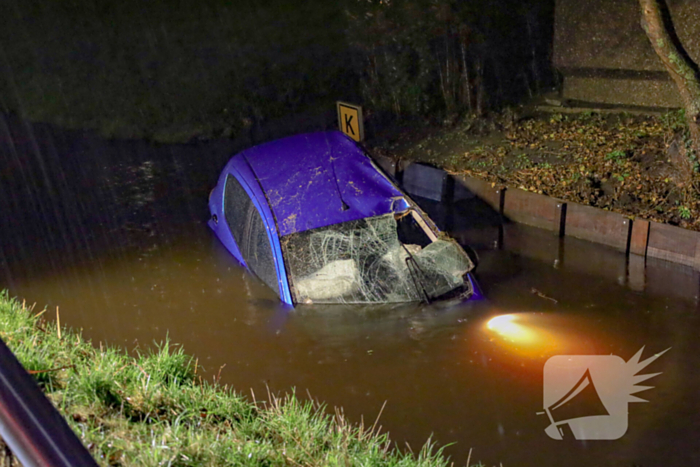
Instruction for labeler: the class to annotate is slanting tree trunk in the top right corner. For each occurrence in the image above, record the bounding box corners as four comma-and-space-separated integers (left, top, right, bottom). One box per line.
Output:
639, 0, 700, 179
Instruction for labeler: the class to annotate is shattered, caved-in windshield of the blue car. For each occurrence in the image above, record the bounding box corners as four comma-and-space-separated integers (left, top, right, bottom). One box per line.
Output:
282, 214, 473, 303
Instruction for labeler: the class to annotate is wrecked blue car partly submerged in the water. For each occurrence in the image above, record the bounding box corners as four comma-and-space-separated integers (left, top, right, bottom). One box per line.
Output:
208, 131, 478, 305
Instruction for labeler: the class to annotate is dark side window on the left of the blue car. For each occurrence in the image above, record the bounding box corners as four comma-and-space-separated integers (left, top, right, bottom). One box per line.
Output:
224, 175, 279, 294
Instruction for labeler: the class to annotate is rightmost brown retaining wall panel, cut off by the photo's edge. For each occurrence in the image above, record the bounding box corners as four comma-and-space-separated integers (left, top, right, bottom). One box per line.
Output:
647, 222, 700, 268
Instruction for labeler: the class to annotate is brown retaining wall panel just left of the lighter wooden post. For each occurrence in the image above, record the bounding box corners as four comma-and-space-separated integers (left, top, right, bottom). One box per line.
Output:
565, 203, 631, 252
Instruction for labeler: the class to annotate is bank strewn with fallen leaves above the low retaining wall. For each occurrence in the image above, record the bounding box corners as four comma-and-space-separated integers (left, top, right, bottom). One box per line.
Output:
373, 110, 700, 230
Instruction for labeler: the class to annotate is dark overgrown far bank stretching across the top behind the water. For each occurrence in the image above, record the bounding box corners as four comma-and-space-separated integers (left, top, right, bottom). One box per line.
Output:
0, 0, 557, 142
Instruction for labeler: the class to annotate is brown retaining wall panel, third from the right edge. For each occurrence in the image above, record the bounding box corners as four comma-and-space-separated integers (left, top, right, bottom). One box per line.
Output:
503, 189, 566, 234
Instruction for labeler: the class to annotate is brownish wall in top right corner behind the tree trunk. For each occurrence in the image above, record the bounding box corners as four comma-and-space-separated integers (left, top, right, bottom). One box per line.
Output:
554, 0, 700, 107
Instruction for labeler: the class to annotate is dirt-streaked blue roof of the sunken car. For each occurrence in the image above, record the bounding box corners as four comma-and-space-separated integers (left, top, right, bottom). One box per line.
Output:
234, 131, 407, 236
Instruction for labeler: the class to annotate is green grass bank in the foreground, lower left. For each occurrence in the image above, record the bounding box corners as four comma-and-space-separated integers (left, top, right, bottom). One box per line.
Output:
0, 292, 470, 467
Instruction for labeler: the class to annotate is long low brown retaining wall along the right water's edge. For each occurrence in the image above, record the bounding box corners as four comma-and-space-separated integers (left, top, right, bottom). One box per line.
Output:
375, 157, 700, 274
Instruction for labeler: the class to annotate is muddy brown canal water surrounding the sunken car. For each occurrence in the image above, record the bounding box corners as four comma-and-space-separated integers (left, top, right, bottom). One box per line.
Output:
0, 114, 700, 466
